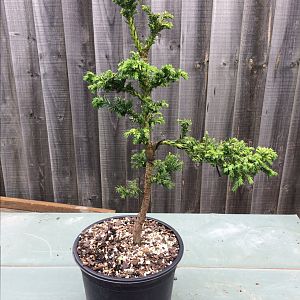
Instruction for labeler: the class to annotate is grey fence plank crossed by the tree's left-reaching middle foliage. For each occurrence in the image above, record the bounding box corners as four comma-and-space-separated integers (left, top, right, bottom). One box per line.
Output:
93, 0, 126, 211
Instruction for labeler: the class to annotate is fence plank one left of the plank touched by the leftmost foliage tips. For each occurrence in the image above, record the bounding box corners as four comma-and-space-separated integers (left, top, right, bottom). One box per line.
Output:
33, 0, 78, 204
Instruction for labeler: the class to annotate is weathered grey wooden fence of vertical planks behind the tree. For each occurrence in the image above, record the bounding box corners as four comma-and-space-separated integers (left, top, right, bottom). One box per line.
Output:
0, 0, 300, 213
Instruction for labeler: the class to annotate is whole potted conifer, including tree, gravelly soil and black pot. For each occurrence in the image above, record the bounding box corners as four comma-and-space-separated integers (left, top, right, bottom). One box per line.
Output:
73, 0, 277, 300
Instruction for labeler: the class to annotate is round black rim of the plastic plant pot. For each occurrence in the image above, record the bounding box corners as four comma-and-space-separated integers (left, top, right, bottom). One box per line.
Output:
72, 215, 184, 284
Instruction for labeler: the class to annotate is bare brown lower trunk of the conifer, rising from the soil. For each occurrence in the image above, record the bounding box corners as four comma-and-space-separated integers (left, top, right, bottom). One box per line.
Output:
133, 145, 154, 244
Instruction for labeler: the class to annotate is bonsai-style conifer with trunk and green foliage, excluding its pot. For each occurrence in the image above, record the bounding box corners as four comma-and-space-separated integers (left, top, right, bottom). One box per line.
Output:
84, 0, 277, 243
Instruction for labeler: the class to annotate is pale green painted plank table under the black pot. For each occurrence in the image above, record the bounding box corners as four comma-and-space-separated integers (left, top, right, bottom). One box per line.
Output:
1, 213, 300, 300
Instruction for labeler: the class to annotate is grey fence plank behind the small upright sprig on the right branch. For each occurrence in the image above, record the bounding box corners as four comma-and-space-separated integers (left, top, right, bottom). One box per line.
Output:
178, 0, 213, 212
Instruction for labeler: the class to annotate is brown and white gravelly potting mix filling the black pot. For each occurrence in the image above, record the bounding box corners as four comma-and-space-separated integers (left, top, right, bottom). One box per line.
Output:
77, 217, 179, 278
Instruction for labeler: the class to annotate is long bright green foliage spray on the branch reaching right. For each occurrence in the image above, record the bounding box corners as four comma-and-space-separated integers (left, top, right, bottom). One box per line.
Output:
163, 134, 277, 191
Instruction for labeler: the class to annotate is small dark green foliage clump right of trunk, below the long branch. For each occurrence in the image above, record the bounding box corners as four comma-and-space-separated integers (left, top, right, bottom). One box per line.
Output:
152, 153, 183, 189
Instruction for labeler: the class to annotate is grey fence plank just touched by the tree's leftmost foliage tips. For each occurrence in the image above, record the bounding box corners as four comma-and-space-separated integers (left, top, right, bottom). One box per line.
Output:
62, 0, 101, 207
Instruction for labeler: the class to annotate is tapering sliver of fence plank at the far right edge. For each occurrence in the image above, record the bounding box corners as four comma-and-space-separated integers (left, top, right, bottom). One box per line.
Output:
277, 68, 300, 214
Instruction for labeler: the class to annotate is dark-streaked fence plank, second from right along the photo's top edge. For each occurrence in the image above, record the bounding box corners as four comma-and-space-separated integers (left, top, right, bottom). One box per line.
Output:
226, 0, 275, 213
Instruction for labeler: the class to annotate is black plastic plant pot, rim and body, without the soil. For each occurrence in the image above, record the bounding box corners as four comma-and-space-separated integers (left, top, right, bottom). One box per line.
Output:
73, 216, 184, 300
